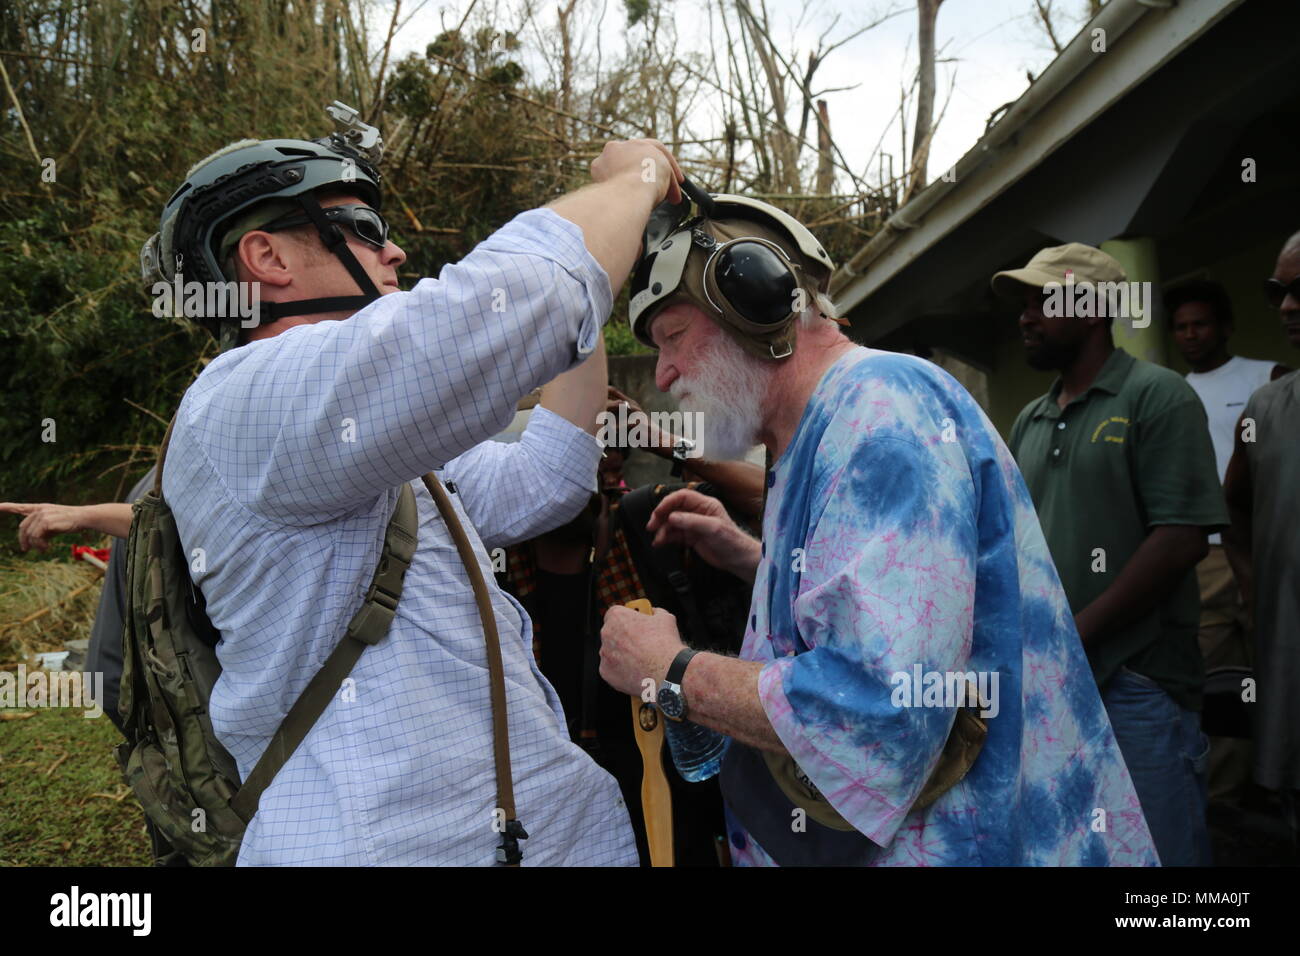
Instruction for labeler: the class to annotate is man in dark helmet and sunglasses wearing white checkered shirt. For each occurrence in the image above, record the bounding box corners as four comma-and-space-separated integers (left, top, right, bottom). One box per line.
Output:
142, 106, 681, 865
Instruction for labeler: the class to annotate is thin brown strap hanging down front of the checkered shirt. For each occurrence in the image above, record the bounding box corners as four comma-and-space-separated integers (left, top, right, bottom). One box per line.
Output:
424, 472, 517, 866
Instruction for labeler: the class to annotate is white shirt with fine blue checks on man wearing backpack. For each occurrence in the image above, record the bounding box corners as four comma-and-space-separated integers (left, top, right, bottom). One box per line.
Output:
164, 209, 637, 866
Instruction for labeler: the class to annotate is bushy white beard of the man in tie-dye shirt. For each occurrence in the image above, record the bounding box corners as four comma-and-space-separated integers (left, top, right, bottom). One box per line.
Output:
668, 333, 770, 462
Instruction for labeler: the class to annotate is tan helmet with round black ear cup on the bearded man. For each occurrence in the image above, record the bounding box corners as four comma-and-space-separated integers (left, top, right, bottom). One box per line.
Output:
628, 182, 839, 360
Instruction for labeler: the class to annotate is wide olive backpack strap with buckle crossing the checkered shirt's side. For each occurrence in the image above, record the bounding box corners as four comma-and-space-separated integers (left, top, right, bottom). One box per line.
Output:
228, 481, 420, 823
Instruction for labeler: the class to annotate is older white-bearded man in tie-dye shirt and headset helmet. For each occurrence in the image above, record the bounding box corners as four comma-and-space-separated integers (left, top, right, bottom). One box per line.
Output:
601, 196, 1157, 865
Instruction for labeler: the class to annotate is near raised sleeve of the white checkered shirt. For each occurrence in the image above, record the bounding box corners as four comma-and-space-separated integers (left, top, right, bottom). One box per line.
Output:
174, 209, 612, 524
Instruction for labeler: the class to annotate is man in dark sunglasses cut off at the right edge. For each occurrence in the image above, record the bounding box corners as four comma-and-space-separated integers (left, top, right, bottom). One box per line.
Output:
1223, 233, 1300, 806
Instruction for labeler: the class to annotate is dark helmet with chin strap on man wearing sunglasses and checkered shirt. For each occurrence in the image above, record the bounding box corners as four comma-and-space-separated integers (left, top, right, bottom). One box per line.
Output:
140, 101, 384, 350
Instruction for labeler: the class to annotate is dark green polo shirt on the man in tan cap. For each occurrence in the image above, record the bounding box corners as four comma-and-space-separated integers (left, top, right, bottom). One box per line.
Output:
1009, 349, 1229, 710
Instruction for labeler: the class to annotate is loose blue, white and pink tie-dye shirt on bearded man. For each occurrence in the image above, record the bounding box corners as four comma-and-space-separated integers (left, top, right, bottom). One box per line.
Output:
728, 347, 1157, 865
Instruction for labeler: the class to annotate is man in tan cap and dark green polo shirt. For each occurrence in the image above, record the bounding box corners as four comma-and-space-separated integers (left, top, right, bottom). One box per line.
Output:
993, 243, 1227, 866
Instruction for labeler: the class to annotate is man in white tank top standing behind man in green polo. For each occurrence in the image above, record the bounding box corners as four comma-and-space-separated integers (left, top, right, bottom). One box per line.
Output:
1165, 280, 1290, 805
